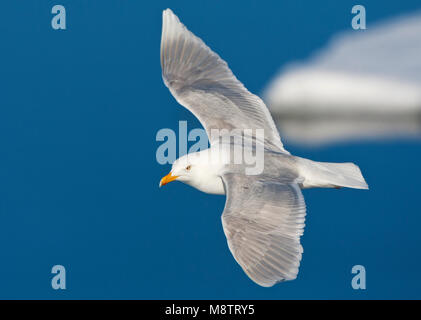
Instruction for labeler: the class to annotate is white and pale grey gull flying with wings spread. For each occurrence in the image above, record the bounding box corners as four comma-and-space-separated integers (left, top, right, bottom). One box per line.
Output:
160, 9, 368, 287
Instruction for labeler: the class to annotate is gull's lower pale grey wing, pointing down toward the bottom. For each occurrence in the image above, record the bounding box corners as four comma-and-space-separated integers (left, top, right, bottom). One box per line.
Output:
222, 174, 306, 287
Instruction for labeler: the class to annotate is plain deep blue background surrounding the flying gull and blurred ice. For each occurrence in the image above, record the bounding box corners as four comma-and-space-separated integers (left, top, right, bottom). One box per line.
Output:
0, 0, 421, 299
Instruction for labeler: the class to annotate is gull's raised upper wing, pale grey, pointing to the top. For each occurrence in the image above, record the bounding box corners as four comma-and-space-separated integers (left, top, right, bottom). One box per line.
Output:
161, 9, 287, 153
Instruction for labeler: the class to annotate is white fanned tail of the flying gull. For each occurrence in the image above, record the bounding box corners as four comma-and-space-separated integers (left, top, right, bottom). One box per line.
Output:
296, 158, 368, 189
